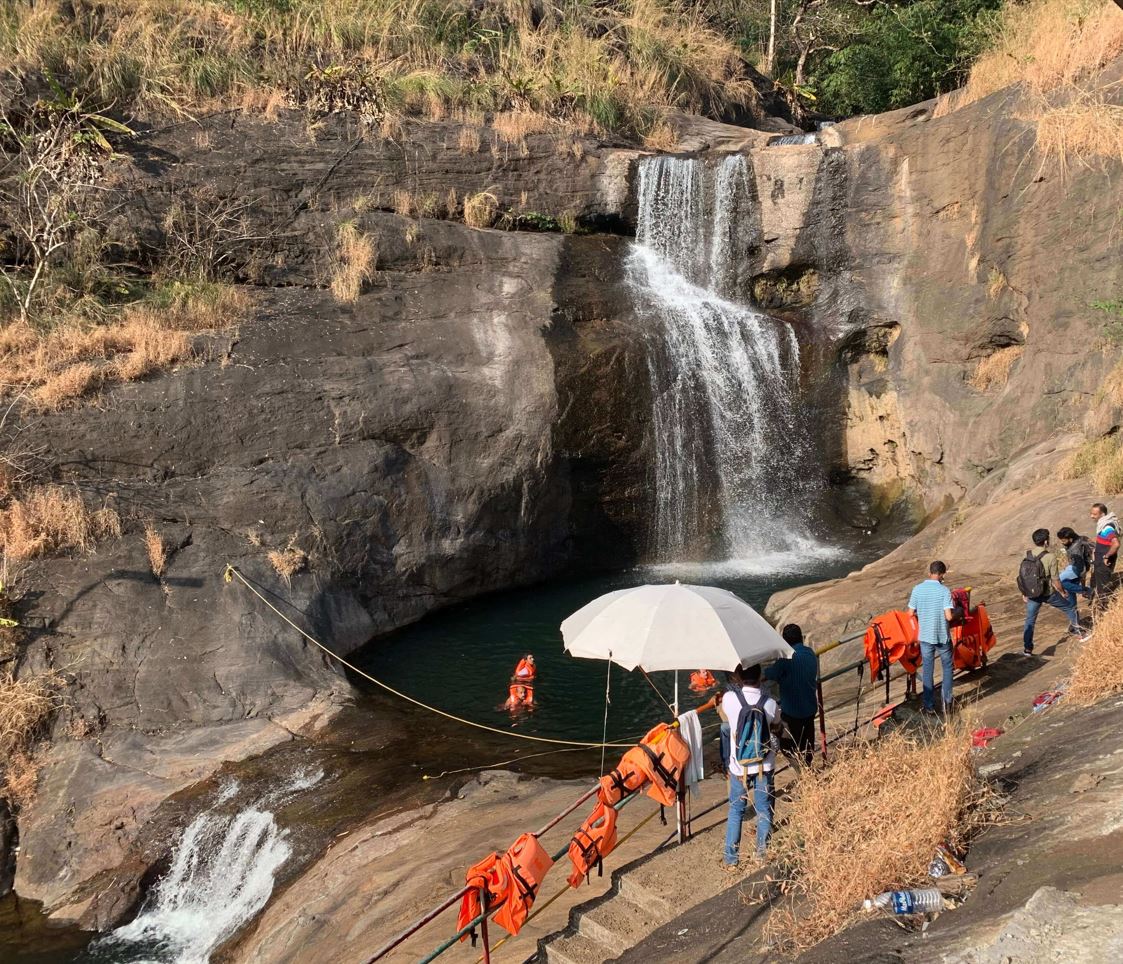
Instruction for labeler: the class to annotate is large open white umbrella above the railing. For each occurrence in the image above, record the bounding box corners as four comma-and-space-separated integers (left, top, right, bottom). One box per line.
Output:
562, 582, 792, 673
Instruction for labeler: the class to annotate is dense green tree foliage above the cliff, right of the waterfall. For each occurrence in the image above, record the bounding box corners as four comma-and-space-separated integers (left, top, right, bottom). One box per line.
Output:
810, 0, 1001, 116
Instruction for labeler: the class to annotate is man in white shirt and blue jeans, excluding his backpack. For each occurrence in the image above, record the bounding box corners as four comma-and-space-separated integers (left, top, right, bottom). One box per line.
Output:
721, 665, 783, 867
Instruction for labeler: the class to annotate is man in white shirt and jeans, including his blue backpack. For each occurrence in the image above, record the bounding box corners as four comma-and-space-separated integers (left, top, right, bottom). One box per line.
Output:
721, 665, 783, 867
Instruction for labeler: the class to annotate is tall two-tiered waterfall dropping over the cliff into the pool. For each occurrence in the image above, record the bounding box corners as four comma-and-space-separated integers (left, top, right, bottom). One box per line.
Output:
627, 155, 823, 571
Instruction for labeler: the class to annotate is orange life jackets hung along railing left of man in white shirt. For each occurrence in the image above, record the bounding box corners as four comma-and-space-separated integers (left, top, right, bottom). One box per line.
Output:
457, 724, 691, 940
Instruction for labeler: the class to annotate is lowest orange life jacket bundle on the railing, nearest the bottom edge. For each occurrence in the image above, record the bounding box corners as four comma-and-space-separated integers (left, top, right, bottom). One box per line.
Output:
456, 834, 554, 943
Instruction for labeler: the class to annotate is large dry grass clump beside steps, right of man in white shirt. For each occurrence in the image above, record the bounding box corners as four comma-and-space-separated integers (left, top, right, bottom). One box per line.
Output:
766, 726, 980, 948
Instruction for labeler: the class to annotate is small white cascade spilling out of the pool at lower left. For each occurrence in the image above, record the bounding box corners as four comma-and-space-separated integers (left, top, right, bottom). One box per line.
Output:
90, 771, 323, 964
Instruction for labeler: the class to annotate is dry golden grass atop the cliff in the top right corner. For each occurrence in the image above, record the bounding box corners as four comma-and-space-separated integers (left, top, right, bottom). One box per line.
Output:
956, 0, 1123, 167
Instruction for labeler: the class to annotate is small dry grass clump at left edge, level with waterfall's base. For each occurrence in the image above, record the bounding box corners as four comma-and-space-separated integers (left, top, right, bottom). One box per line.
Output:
0, 485, 121, 560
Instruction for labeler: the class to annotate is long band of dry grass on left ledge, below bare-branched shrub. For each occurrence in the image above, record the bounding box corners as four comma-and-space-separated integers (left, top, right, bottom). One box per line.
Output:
0, 285, 248, 411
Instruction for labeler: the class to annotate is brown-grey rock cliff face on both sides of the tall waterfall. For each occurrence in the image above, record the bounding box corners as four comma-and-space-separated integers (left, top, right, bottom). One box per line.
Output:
16, 63, 1123, 926
